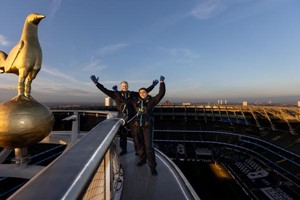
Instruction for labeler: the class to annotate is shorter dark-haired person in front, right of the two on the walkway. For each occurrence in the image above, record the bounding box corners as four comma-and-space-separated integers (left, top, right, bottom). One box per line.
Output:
133, 76, 166, 176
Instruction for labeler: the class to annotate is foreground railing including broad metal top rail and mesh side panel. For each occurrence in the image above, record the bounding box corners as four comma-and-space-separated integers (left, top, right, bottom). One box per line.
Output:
9, 114, 124, 200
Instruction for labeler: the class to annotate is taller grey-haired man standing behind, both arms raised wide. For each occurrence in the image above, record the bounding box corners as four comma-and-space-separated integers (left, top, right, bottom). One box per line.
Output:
90, 75, 158, 156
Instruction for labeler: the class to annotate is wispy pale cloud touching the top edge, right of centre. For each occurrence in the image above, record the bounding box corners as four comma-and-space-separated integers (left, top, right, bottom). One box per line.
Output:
189, 0, 226, 20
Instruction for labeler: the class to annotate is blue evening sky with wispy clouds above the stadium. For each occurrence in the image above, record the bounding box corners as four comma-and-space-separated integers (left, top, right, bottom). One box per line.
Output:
0, 0, 300, 103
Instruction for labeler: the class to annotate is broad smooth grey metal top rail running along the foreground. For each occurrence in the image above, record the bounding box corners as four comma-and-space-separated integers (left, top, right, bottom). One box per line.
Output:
9, 118, 124, 200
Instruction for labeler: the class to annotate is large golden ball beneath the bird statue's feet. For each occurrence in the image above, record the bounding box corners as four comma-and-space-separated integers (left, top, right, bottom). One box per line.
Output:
0, 98, 54, 148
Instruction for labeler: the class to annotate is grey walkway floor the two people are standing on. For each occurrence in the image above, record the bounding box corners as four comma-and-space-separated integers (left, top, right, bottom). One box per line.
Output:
120, 141, 199, 200
